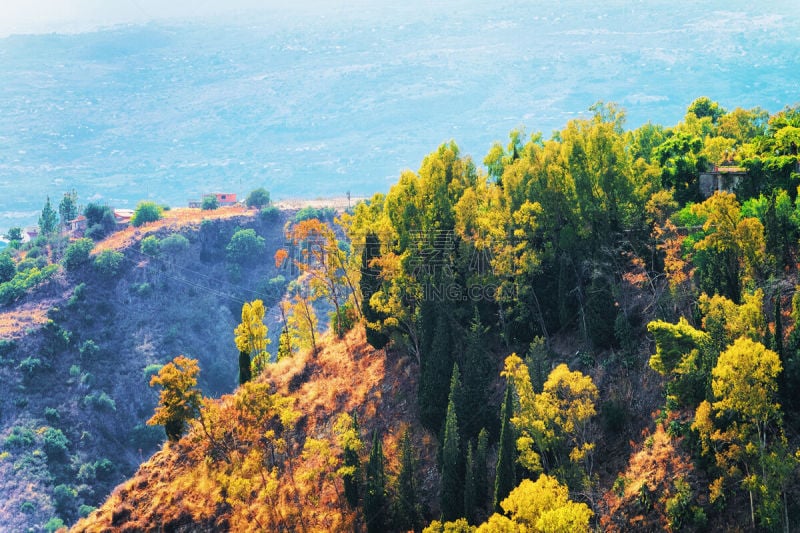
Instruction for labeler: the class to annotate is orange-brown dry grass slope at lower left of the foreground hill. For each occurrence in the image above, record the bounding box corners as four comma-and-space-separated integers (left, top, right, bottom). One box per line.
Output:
73, 327, 438, 532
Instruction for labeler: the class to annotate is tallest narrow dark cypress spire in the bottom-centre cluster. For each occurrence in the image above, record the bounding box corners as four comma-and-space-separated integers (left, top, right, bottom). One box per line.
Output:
441, 365, 464, 521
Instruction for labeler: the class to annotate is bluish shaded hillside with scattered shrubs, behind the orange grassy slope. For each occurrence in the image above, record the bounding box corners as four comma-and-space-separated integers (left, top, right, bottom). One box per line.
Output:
0, 209, 294, 531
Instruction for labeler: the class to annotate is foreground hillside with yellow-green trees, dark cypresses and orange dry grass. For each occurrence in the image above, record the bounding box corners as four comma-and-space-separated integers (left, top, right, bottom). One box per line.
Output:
7, 98, 800, 532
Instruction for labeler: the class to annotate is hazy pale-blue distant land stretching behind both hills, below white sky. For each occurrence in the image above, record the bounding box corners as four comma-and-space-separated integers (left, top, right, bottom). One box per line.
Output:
0, 0, 800, 232
